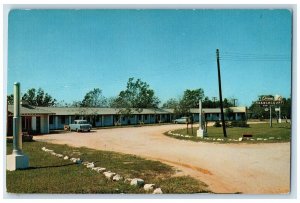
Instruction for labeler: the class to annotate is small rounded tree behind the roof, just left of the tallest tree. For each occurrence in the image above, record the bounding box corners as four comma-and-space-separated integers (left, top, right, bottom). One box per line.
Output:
80, 88, 107, 107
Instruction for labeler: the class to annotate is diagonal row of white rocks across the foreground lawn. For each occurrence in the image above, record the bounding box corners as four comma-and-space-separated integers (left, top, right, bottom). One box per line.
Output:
42, 147, 163, 194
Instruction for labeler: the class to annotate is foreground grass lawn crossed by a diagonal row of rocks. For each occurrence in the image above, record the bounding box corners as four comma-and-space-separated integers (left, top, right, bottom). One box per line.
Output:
6, 142, 210, 194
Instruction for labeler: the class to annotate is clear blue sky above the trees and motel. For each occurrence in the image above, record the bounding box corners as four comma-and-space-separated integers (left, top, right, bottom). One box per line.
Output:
7, 9, 291, 106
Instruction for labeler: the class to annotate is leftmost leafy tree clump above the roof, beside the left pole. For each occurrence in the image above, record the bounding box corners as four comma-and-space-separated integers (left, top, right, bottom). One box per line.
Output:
22, 88, 56, 106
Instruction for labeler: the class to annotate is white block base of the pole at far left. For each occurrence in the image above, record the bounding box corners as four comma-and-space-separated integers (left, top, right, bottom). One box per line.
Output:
6, 154, 29, 171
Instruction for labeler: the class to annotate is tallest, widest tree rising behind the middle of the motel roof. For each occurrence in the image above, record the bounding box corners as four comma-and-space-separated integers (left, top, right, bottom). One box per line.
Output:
110, 78, 160, 122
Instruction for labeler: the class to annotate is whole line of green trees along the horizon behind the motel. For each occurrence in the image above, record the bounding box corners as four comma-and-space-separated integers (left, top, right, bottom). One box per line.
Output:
7, 77, 291, 118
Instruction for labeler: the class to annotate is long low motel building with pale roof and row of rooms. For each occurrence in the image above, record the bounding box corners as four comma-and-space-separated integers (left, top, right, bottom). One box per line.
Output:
7, 105, 246, 136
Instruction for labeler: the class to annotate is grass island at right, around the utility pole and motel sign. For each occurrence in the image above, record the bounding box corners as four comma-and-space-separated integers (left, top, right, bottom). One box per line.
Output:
165, 123, 291, 143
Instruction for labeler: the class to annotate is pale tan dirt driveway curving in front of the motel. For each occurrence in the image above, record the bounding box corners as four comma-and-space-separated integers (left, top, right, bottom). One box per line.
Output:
35, 124, 290, 194
